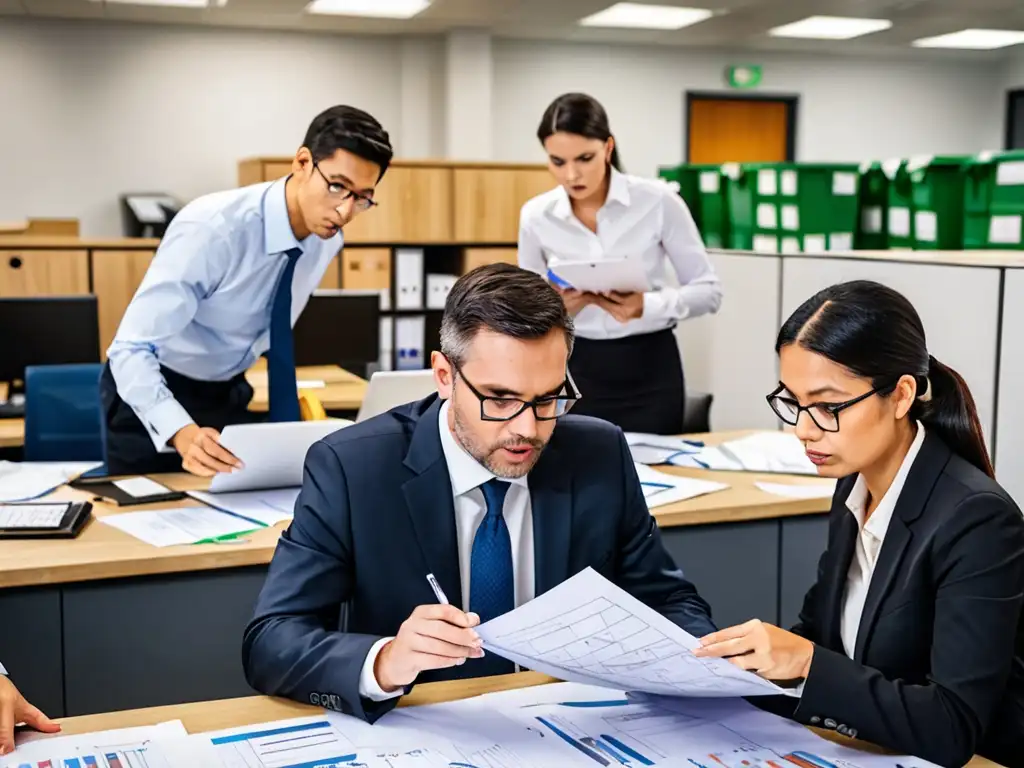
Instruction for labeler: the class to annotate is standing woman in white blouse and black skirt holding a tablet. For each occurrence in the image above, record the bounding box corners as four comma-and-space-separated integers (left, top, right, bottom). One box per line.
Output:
519, 93, 722, 434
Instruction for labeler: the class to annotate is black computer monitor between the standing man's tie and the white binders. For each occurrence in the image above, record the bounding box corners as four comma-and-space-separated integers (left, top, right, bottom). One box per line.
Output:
294, 291, 381, 376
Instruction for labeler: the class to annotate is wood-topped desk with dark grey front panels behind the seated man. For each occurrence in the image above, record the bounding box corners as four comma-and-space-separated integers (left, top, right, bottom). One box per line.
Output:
0, 434, 828, 716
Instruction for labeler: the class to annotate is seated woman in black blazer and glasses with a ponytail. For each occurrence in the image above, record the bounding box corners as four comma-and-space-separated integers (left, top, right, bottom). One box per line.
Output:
696, 281, 1024, 768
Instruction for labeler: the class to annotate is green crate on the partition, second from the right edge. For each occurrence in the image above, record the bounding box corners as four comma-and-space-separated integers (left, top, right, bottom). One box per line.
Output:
888, 156, 971, 251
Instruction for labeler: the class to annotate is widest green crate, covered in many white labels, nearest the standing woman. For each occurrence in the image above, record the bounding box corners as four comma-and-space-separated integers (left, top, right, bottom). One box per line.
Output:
723, 163, 859, 253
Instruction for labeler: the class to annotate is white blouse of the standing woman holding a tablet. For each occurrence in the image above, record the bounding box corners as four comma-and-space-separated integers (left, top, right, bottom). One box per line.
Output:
519, 168, 722, 339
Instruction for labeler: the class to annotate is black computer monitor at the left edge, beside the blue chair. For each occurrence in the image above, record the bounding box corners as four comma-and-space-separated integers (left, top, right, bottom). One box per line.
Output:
0, 296, 99, 391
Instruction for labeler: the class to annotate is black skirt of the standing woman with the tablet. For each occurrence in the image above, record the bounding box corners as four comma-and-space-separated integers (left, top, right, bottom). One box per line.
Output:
569, 329, 685, 434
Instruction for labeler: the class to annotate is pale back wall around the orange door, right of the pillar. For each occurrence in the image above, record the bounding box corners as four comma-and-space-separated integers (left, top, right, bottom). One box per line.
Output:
494, 40, 1001, 175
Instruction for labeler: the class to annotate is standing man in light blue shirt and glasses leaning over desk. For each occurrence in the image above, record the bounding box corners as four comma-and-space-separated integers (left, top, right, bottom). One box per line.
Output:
100, 106, 392, 476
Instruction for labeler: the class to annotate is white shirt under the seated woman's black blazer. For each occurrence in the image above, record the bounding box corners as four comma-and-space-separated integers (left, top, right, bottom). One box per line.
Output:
840, 422, 925, 658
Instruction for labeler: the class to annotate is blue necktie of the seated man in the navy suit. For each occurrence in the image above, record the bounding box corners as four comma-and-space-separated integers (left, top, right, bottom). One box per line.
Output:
466, 478, 515, 677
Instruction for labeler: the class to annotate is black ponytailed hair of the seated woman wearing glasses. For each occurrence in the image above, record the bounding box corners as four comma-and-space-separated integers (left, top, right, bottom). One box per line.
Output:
775, 281, 995, 477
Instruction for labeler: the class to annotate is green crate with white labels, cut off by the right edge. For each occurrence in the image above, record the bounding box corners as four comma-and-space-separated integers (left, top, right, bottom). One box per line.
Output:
964, 151, 1024, 251
